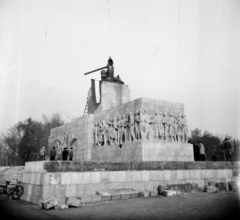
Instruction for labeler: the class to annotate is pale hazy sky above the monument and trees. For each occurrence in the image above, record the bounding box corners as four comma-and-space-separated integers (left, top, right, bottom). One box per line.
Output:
0, 0, 240, 138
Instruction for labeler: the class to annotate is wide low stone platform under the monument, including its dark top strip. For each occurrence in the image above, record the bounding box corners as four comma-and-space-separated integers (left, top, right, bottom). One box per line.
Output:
21, 161, 239, 204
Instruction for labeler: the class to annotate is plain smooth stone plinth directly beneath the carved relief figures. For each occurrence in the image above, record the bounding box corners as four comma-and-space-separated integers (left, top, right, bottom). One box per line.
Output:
91, 140, 194, 162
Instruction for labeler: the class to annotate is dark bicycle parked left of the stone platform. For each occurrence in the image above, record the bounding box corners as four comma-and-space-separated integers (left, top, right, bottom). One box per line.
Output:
0, 179, 24, 199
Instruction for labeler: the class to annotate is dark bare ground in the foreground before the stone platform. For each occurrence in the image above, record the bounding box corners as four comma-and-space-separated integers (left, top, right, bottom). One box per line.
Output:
0, 193, 240, 220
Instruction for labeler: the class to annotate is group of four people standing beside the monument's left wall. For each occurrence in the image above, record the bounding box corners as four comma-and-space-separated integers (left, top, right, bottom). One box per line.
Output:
40, 147, 73, 161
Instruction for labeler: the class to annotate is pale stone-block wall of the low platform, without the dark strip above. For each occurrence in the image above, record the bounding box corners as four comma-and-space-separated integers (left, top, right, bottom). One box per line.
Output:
19, 162, 239, 204
